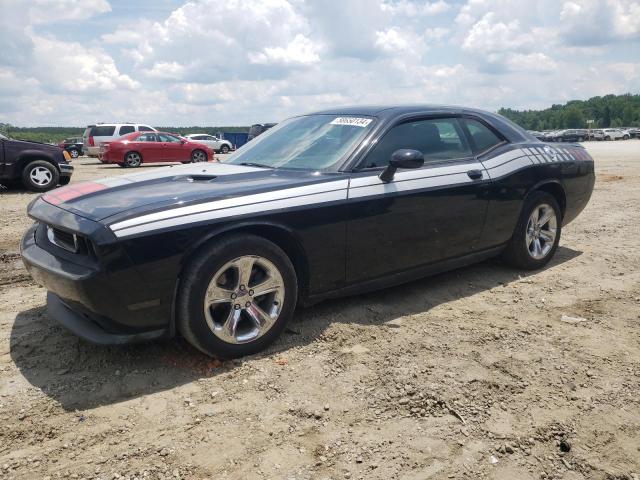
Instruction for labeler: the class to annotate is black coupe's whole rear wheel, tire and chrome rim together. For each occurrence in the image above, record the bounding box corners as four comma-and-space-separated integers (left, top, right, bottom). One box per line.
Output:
503, 191, 562, 270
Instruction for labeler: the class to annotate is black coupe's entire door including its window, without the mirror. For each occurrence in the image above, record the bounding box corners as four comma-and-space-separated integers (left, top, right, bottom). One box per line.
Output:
346, 116, 490, 283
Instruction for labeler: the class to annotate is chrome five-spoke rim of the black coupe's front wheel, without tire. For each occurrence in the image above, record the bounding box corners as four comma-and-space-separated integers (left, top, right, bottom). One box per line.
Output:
204, 255, 285, 344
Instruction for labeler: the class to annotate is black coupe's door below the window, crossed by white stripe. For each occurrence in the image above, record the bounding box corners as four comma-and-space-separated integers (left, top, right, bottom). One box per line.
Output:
347, 162, 488, 283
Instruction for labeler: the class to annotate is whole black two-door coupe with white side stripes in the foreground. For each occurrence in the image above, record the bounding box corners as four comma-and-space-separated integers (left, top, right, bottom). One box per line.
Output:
22, 106, 595, 358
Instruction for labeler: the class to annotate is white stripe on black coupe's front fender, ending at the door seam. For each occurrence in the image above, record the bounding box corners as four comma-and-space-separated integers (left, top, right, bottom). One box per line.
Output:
110, 179, 349, 237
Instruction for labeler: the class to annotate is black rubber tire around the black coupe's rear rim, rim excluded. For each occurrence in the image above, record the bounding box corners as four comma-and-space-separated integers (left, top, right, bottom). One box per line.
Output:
502, 191, 562, 270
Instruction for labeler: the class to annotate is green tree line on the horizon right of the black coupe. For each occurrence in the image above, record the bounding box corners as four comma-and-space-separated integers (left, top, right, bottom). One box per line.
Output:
498, 93, 640, 130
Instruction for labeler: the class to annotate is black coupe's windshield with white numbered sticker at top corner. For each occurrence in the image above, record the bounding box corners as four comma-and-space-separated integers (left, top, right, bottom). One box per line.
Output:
225, 115, 373, 170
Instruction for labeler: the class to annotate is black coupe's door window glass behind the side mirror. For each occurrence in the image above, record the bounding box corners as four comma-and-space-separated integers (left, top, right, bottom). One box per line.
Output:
361, 118, 471, 168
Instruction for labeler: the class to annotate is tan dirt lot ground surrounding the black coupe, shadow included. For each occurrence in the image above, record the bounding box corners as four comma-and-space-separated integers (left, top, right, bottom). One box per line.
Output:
0, 144, 640, 480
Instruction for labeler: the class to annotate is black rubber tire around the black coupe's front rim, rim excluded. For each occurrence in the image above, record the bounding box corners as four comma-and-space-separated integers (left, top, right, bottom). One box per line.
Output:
175, 234, 298, 358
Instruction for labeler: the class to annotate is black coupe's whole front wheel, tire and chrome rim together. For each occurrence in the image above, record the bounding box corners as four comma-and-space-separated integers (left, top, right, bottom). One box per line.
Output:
176, 235, 298, 358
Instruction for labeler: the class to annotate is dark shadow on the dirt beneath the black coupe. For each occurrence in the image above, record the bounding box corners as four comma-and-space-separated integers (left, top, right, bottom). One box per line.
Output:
10, 247, 582, 411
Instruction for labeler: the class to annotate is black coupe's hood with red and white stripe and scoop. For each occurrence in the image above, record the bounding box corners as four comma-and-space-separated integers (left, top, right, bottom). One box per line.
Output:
42, 163, 341, 224
